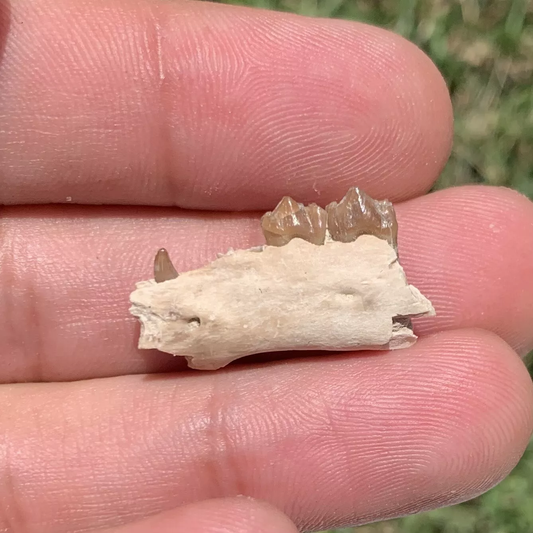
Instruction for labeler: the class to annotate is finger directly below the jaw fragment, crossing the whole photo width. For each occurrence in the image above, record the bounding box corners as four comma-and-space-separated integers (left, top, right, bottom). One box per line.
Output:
0, 330, 533, 533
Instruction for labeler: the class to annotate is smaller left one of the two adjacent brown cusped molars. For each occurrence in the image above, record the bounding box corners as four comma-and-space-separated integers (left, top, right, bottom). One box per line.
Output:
261, 196, 327, 246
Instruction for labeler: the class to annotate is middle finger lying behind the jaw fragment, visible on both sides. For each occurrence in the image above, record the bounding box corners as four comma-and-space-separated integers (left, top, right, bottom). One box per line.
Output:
0, 187, 533, 382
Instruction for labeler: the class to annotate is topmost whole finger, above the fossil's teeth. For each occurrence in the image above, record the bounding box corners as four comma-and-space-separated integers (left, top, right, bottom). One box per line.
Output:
0, 0, 452, 210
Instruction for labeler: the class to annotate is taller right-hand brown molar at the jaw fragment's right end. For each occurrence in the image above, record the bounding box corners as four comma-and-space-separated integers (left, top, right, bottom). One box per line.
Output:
326, 187, 398, 250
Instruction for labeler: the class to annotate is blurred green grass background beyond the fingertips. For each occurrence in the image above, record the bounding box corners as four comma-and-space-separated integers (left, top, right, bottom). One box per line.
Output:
215, 0, 533, 533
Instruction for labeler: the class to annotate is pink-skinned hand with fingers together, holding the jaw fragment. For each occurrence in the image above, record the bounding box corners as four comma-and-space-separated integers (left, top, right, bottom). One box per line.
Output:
0, 0, 533, 533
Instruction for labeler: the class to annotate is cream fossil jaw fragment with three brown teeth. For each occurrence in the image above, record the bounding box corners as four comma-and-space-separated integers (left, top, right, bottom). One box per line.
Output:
130, 189, 435, 370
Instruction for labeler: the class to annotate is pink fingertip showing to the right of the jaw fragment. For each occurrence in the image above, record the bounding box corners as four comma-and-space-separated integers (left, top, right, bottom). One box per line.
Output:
399, 187, 533, 355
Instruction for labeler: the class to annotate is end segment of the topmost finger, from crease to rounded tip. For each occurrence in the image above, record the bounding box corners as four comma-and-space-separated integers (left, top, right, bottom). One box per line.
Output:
158, 2, 453, 209
